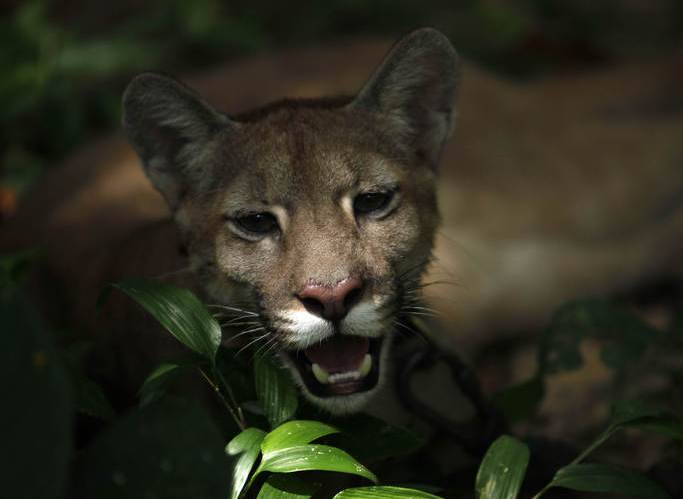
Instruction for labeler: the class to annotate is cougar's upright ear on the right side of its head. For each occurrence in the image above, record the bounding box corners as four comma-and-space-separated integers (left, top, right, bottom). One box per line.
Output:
350, 28, 459, 167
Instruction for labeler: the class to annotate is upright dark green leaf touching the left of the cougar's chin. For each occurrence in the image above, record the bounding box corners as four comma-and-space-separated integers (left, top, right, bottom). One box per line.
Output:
254, 356, 299, 428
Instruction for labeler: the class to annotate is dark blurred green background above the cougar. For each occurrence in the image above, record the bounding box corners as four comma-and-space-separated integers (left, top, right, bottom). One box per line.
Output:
0, 0, 683, 211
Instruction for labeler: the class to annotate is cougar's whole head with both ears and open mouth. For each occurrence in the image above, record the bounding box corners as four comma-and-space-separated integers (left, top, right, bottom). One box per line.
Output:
124, 29, 458, 413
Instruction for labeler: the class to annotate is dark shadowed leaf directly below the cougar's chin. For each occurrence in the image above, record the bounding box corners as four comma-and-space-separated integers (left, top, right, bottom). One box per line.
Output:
327, 414, 425, 463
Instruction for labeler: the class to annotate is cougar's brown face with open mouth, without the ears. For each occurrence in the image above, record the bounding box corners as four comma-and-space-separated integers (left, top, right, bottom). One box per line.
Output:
183, 106, 437, 412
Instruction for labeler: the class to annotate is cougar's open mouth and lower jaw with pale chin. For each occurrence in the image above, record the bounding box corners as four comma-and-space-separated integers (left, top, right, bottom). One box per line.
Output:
280, 334, 392, 414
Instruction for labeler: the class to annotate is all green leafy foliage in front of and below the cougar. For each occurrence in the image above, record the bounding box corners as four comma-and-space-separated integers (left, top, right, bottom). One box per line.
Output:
0, 255, 683, 499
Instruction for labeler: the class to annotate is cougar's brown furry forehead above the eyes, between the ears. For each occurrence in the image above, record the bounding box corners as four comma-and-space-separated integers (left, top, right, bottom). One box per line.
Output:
215, 109, 401, 208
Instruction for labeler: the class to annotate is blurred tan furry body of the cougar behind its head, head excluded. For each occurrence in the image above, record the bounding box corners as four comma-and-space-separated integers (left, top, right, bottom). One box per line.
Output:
1, 35, 683, 400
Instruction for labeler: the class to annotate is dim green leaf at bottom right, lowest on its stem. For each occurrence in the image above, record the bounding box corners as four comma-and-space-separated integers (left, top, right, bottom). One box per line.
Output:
548, 464, 670, 499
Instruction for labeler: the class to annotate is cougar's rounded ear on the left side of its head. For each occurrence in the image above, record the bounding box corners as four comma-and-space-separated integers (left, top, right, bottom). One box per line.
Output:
123, 73, 233, 210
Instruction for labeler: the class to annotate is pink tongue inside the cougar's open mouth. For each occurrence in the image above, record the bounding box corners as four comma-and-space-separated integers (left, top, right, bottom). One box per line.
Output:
304, 335, 370, 374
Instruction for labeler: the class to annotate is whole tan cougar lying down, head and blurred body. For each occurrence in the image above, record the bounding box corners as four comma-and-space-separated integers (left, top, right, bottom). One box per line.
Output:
5, 28, 683, 413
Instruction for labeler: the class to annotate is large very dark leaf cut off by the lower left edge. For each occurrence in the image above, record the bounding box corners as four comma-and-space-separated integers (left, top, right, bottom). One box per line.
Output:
0, 296, 74, 499
